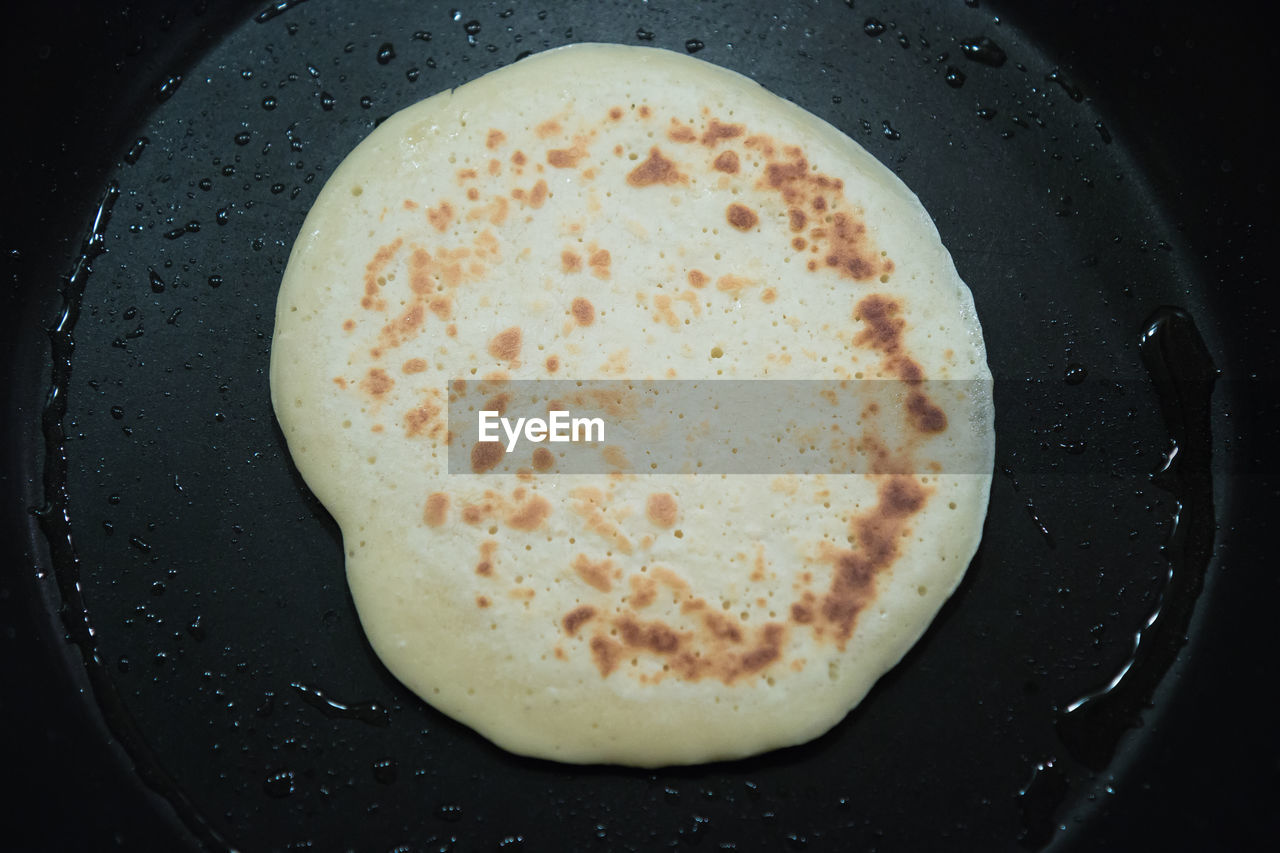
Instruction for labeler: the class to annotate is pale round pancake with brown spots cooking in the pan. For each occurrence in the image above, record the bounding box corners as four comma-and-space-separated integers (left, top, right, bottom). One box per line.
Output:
270, 45, 993, 766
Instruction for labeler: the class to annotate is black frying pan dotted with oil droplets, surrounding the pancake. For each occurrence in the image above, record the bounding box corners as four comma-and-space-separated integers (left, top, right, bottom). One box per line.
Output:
0, 0, 1280, 850
